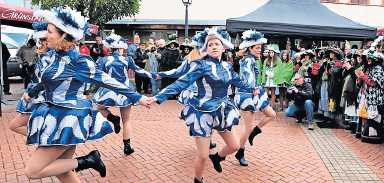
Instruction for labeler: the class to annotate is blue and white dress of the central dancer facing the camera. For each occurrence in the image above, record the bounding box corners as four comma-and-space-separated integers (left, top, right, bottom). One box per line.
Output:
155, 56, 253, 137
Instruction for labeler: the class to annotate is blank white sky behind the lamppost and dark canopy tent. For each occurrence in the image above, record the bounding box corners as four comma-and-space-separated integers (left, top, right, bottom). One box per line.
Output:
135, 0, 384, 27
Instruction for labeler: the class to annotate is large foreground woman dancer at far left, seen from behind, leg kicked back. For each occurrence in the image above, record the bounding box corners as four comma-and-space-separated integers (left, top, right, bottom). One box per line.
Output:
24, 7, 148, 182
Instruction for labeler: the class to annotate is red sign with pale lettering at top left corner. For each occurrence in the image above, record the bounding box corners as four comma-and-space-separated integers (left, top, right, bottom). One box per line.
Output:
0, 4, 41, 23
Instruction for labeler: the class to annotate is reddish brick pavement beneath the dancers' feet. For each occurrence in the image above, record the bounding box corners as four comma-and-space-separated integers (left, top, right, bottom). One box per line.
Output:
0, 91, 384, 183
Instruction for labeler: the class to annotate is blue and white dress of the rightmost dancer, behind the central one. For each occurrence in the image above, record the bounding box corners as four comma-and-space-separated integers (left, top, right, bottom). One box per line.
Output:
234, 54, 269, 112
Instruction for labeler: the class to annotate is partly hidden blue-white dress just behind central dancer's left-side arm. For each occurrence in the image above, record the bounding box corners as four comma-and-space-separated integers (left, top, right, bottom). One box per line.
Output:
158, 60, 197, 105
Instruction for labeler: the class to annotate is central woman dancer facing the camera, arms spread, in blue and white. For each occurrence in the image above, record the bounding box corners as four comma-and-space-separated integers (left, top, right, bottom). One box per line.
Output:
150, 28, 254, 182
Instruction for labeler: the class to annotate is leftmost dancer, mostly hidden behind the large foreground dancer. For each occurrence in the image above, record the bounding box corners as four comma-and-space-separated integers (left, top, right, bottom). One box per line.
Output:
9, 21, 48, 136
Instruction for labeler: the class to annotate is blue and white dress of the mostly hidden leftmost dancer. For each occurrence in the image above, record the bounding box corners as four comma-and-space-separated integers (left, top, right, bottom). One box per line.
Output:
16, 51, 49, 114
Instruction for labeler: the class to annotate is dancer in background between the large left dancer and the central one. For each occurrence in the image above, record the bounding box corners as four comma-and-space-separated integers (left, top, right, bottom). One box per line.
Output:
93, 34, 156, 155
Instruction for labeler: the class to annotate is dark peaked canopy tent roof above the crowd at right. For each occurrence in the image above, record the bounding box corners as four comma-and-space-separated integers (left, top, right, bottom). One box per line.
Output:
227, 0, 376, 40
